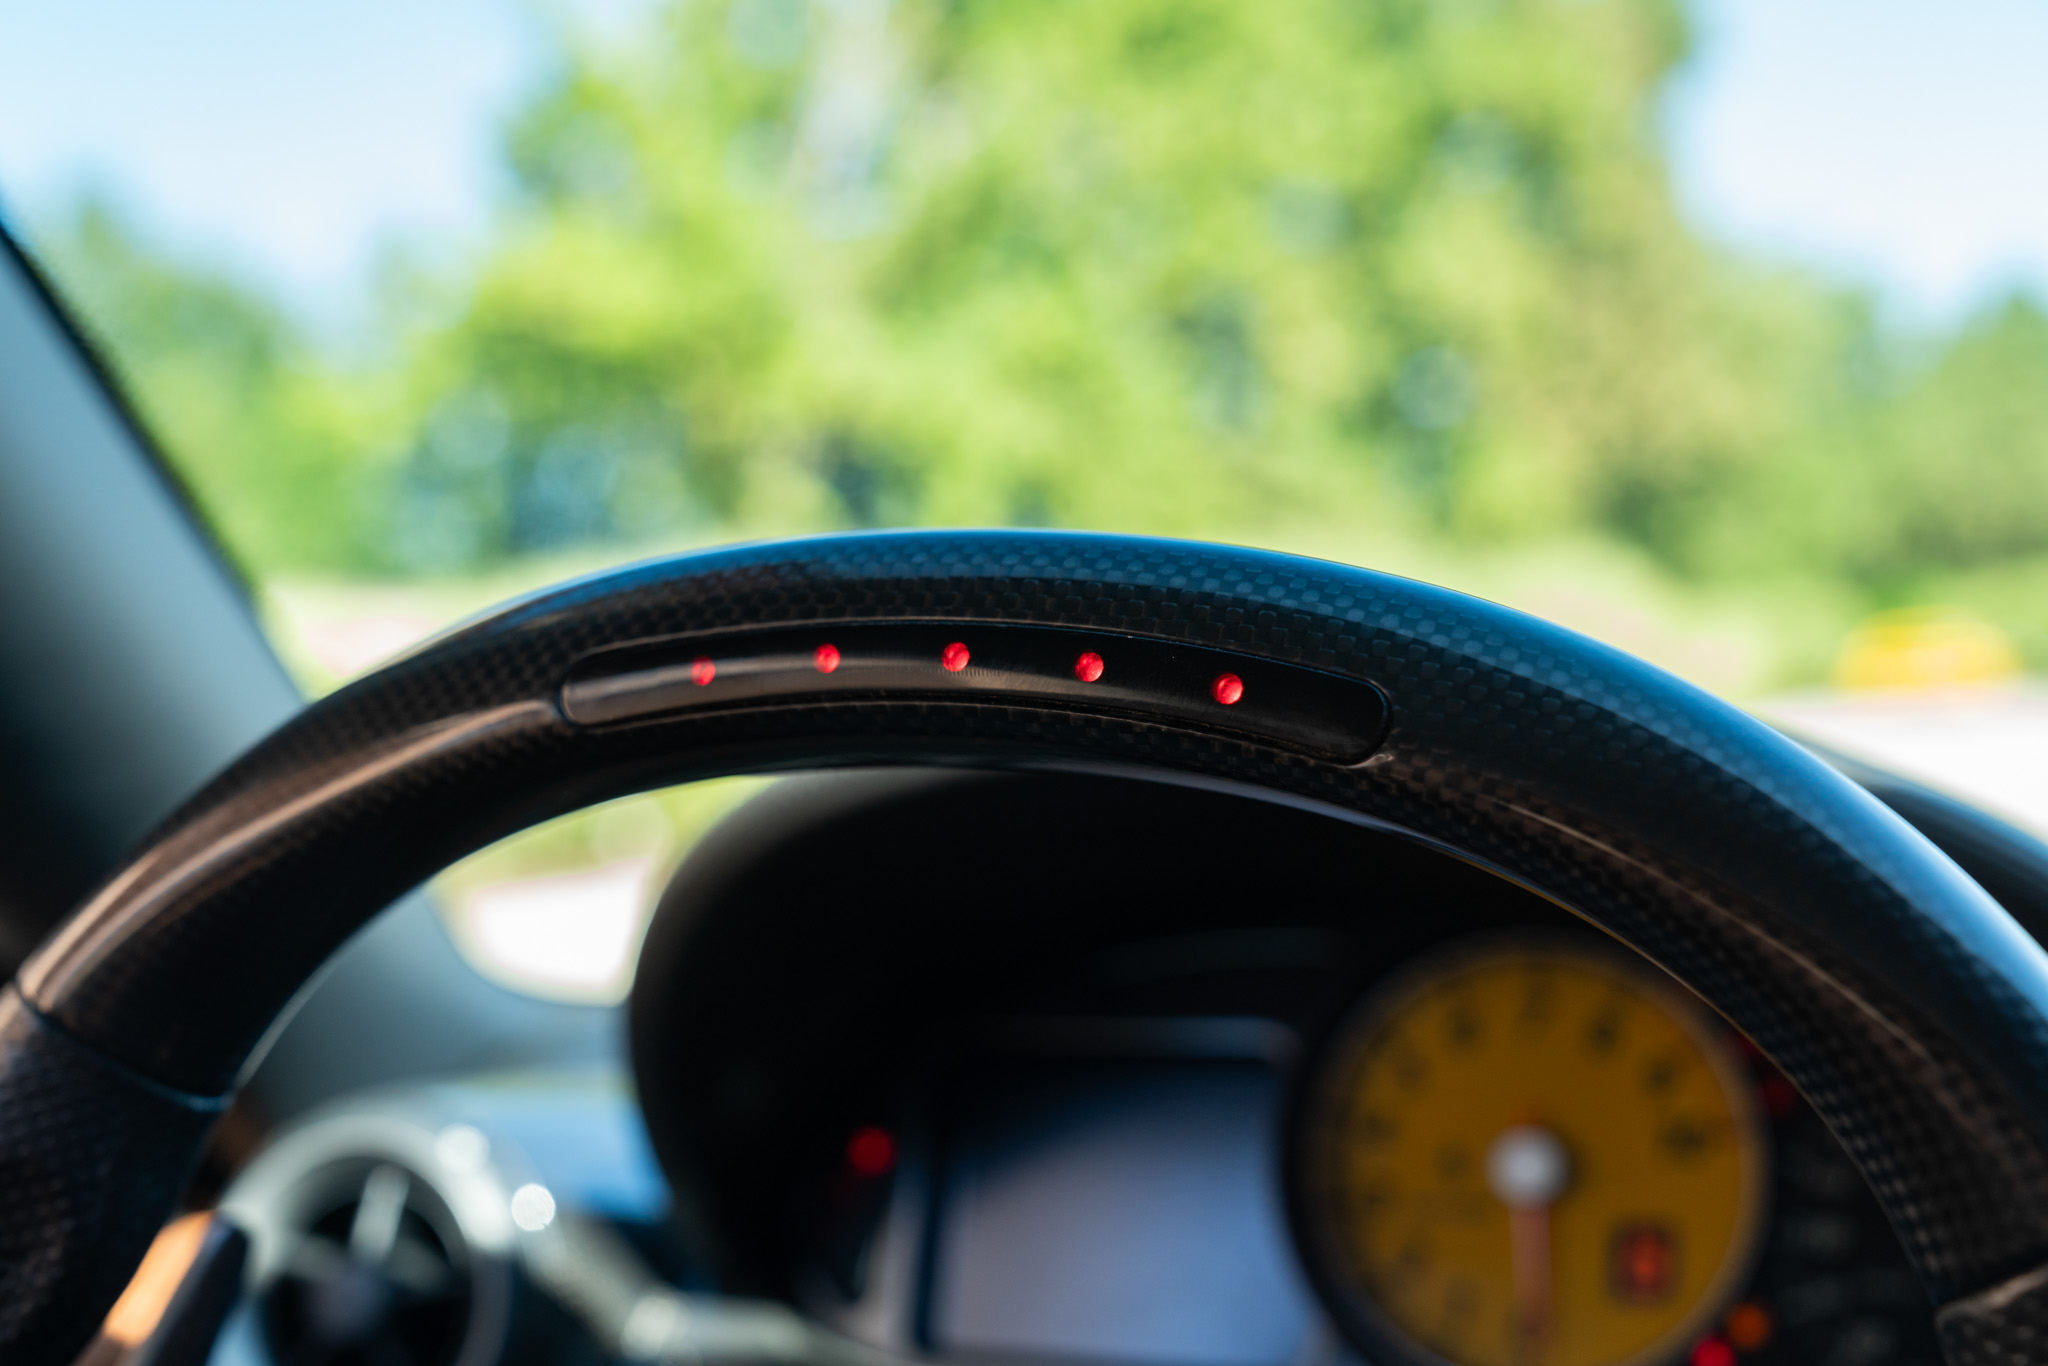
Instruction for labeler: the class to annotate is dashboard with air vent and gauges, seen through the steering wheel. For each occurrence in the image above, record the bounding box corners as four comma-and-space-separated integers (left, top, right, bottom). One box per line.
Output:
215, 772, 1939, 1366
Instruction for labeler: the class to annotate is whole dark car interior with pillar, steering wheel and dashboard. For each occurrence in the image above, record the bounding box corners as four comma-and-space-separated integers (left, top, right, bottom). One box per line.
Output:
0, 96, 2048, 1366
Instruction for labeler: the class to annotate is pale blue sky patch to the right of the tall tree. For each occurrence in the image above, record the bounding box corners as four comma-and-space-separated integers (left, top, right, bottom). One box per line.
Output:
1671, 0, 2048, 317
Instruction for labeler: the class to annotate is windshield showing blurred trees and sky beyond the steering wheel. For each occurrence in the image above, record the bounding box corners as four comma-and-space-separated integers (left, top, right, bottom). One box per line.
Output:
0, 0, 2048, 993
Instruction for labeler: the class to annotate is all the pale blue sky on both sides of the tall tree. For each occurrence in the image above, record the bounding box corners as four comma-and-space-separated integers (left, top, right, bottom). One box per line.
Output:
0, 0, 2048, 319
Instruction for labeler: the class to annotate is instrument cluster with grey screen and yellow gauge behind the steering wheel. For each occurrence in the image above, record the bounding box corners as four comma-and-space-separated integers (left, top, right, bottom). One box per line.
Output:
803, 928, 1939, 1366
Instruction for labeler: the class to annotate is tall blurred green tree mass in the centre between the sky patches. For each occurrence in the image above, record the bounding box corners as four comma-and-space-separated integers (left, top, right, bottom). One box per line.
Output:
420, 0, 1784, 549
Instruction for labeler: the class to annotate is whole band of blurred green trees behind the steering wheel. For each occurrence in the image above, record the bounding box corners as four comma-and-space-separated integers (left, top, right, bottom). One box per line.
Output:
32, 0, 2048, 655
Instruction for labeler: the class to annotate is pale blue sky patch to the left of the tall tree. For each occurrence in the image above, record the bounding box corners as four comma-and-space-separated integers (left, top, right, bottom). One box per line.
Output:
0, 0, 645, 303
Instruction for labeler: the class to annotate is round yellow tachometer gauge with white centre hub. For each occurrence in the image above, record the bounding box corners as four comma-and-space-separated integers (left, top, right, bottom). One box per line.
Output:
1294, 940, 1765, 1366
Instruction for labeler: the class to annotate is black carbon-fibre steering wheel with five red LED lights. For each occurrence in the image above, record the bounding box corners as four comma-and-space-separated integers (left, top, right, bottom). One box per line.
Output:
0, 532, 2048, 1366
